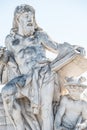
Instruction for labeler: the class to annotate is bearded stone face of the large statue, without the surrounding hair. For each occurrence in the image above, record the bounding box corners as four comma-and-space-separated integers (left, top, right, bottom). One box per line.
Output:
18, 12, 34, 36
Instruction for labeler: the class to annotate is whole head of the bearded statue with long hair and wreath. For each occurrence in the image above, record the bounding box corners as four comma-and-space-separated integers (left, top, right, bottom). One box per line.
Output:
13, 5, 38, 35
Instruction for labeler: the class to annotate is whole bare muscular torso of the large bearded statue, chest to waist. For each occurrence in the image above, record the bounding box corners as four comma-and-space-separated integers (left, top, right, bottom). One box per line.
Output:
7, 32, 46, 74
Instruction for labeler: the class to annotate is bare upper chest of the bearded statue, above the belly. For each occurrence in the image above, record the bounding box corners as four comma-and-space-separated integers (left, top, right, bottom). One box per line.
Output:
12, 37, 45, 60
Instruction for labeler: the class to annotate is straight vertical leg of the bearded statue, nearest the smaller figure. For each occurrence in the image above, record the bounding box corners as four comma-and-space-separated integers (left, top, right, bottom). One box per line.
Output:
40, 80, 54, 130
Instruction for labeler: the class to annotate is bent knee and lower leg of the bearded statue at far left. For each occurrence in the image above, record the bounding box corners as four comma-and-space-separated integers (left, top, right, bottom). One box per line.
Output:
2, 82, 25, 130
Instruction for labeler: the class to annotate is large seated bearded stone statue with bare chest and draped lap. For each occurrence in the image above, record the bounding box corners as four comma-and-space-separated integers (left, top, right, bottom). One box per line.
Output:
0, 5, 85, 130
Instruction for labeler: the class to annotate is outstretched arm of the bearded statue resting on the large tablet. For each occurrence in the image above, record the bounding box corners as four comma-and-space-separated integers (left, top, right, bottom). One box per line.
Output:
39, 31, 85, 56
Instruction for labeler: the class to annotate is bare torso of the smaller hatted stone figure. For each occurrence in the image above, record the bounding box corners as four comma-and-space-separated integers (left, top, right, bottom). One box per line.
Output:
62, 98, 83, 129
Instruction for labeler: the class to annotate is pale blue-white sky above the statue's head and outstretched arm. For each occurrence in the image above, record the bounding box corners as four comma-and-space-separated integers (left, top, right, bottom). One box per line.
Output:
0, 0, 87, 48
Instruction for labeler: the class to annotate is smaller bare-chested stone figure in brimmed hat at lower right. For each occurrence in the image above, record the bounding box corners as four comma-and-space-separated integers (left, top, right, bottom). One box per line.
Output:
54, 77, 87, 130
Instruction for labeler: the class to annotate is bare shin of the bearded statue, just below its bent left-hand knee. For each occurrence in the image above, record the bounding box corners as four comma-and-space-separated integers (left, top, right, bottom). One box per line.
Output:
3, 96, 25, 130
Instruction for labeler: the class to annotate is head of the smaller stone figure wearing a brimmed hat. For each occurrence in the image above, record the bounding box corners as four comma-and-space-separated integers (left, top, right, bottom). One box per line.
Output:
65, 76, 87, 101
